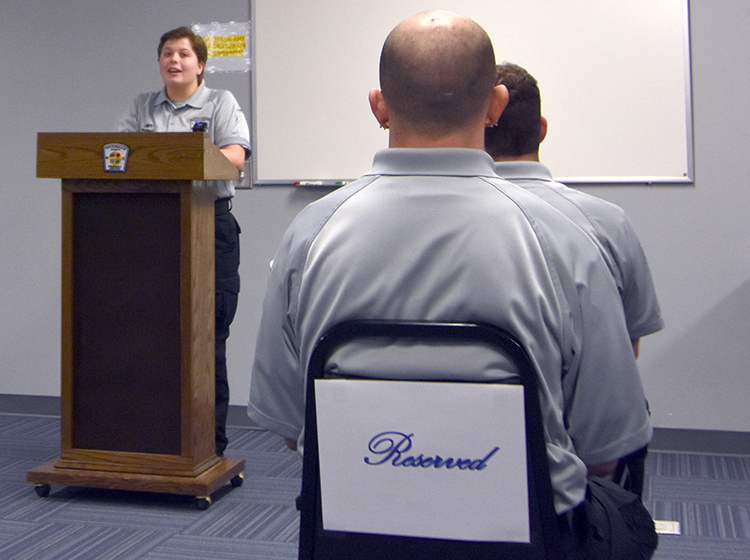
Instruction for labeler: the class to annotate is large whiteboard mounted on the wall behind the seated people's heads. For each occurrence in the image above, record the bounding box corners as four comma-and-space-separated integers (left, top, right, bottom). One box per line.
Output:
251, 0, 693, 185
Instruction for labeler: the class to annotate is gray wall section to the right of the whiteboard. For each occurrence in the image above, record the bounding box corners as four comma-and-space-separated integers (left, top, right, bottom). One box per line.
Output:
589, 0, 750, 431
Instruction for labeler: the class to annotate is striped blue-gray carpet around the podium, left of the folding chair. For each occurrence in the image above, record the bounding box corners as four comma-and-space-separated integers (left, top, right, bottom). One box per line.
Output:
0, 415, 302, 560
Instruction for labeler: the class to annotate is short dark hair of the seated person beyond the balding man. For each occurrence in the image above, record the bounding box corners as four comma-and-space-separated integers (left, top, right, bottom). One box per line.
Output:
484, 62, 542, 158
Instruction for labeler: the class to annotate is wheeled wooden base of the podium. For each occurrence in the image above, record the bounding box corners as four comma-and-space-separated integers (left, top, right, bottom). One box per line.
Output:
26, 457, 245, 509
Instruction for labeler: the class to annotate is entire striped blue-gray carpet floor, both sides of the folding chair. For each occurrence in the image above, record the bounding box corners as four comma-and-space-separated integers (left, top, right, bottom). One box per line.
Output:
0, 414, 750, 560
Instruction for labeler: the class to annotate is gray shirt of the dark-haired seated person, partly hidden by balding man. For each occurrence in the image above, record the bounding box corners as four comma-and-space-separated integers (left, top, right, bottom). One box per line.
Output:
495, 161, 664, 340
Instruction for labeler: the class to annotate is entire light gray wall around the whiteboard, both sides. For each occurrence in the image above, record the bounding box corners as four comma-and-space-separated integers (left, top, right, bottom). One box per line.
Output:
0, 0, 750, 432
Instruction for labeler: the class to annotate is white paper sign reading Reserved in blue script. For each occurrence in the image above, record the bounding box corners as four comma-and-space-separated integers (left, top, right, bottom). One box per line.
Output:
315, 379, 529, 543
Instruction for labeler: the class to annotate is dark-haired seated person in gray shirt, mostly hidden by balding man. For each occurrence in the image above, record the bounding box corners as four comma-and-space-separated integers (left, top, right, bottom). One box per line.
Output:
484, 62, 664, 496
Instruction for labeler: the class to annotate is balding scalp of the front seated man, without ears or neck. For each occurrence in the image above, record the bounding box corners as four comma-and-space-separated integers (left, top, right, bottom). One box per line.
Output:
380, 11, 495, 134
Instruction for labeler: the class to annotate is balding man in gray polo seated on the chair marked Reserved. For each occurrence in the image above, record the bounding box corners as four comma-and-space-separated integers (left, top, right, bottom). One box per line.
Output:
248, 11, 656, 558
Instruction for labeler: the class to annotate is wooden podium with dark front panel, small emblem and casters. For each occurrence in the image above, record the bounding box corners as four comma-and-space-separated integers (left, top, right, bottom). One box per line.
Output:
27, 133, 245, 508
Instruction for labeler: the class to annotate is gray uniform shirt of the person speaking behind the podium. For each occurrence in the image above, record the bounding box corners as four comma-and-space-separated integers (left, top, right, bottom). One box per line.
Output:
115, 82, 250, 198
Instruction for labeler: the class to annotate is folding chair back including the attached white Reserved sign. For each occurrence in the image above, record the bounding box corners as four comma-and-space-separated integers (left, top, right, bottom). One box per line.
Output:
299, 321, 559, 560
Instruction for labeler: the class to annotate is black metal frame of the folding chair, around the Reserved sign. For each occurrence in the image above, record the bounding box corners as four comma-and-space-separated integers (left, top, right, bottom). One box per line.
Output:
298, 321, 561, 560
